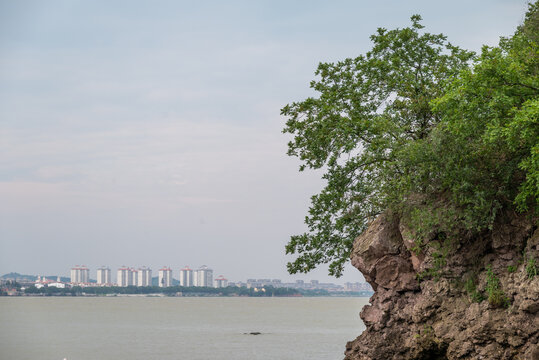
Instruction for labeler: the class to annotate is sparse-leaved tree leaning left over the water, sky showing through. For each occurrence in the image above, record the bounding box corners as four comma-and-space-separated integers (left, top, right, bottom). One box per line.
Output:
281, 15, 473, 276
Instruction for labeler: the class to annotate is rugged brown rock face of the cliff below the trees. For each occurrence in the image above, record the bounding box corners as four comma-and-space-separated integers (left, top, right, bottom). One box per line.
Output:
345, 215, 539, 360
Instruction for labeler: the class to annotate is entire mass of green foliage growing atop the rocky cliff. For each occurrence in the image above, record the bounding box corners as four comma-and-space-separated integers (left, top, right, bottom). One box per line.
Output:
281, 2, 539, 276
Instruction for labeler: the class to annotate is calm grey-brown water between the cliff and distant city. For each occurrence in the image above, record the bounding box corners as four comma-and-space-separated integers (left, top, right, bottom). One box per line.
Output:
0, 297, 368, 360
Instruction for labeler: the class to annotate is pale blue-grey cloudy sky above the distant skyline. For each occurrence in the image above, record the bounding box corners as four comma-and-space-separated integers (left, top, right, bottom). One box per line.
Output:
0, 0, 527, 283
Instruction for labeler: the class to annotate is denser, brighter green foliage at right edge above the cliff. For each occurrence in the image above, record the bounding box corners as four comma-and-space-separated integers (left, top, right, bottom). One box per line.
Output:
435, 4, 539, 219
